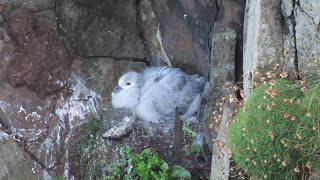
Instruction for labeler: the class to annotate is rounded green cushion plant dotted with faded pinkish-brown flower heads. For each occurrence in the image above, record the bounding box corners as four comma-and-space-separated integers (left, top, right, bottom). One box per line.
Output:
229, 79, 320, 180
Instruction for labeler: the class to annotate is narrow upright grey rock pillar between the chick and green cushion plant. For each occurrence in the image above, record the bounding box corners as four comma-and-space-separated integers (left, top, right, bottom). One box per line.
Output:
204, 22, 236, 179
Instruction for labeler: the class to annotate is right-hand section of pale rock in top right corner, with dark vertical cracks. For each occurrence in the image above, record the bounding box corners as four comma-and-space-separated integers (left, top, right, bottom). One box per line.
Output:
281, 0, 320, 77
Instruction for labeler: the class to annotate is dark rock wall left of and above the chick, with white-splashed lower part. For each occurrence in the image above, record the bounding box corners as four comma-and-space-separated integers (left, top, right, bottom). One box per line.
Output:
0, 0, 216, 179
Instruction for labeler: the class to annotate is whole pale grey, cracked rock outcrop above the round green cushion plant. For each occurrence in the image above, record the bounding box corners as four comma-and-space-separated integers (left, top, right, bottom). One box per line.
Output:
243, 0, 320, 97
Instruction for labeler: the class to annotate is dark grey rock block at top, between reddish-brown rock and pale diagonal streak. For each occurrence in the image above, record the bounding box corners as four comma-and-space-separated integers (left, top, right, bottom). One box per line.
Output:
57, 0, 147, 60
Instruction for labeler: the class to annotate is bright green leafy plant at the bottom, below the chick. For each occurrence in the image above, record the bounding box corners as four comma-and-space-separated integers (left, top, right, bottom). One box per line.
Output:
106, 146, 191, 180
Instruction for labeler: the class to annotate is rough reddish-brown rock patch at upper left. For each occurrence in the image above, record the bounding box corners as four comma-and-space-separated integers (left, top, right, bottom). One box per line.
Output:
7, 8, 69, 98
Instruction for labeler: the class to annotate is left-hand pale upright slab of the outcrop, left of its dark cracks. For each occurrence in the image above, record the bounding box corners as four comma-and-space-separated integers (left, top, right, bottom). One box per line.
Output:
243, 0, 283, 98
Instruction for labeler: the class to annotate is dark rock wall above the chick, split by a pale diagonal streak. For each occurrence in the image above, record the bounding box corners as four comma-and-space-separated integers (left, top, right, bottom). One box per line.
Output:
57, 0, 216, 74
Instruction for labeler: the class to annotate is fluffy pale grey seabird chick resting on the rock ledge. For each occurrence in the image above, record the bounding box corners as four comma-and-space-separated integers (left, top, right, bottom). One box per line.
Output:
112, 67, 206, 123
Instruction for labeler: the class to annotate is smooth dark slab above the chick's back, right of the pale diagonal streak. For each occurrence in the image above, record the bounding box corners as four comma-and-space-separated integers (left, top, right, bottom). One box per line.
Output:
150, 0, 217, 75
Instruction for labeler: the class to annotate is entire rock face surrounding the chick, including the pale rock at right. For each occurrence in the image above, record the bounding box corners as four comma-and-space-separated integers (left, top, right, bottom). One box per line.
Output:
0, 0, 320, 180
